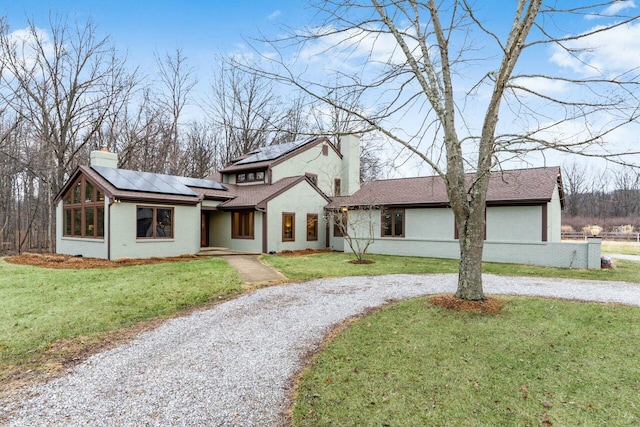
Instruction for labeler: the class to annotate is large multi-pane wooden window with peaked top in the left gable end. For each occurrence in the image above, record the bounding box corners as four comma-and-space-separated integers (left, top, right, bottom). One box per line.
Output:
62, 176, 104, 239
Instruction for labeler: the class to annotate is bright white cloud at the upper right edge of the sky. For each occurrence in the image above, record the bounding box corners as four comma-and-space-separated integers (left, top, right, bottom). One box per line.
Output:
550, 22, 640, 76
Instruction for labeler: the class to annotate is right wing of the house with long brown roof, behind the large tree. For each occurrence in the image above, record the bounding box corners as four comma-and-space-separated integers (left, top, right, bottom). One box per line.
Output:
327, 167, 600, 268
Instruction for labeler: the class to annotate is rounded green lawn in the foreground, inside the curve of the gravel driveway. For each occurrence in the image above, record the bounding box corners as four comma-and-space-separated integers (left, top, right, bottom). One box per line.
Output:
293, 297, 640, 426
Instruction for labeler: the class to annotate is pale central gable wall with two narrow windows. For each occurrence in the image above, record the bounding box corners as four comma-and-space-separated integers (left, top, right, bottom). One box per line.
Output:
267, 181, 327, 252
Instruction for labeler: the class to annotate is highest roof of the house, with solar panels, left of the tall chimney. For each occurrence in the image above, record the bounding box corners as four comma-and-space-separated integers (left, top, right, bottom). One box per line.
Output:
220, 137, 340, 173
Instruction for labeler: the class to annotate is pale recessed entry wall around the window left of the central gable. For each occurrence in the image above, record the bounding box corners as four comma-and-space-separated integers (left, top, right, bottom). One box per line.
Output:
209, 211, 263, 253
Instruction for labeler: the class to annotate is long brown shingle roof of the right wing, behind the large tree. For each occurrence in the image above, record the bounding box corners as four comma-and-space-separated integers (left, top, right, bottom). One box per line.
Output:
329, 166, 562, 208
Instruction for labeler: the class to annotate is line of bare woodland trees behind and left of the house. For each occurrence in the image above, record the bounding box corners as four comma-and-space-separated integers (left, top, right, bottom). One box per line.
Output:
0, 16, 381, 253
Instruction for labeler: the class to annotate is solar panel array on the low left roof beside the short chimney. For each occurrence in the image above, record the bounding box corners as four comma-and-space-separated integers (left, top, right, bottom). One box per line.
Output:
92, 166, 200, 196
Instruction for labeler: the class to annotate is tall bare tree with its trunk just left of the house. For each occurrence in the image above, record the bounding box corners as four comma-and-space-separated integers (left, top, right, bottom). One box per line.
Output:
0, 17, 136, 251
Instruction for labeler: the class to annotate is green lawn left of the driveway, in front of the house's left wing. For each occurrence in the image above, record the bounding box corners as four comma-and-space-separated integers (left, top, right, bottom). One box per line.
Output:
0, 260, 242, 372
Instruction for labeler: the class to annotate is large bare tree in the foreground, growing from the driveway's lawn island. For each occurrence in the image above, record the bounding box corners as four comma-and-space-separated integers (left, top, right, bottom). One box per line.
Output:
246, 0, 639, 300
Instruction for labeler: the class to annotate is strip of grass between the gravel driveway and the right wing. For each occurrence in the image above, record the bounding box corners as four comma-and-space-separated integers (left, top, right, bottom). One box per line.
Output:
262, 252, 640, 283
